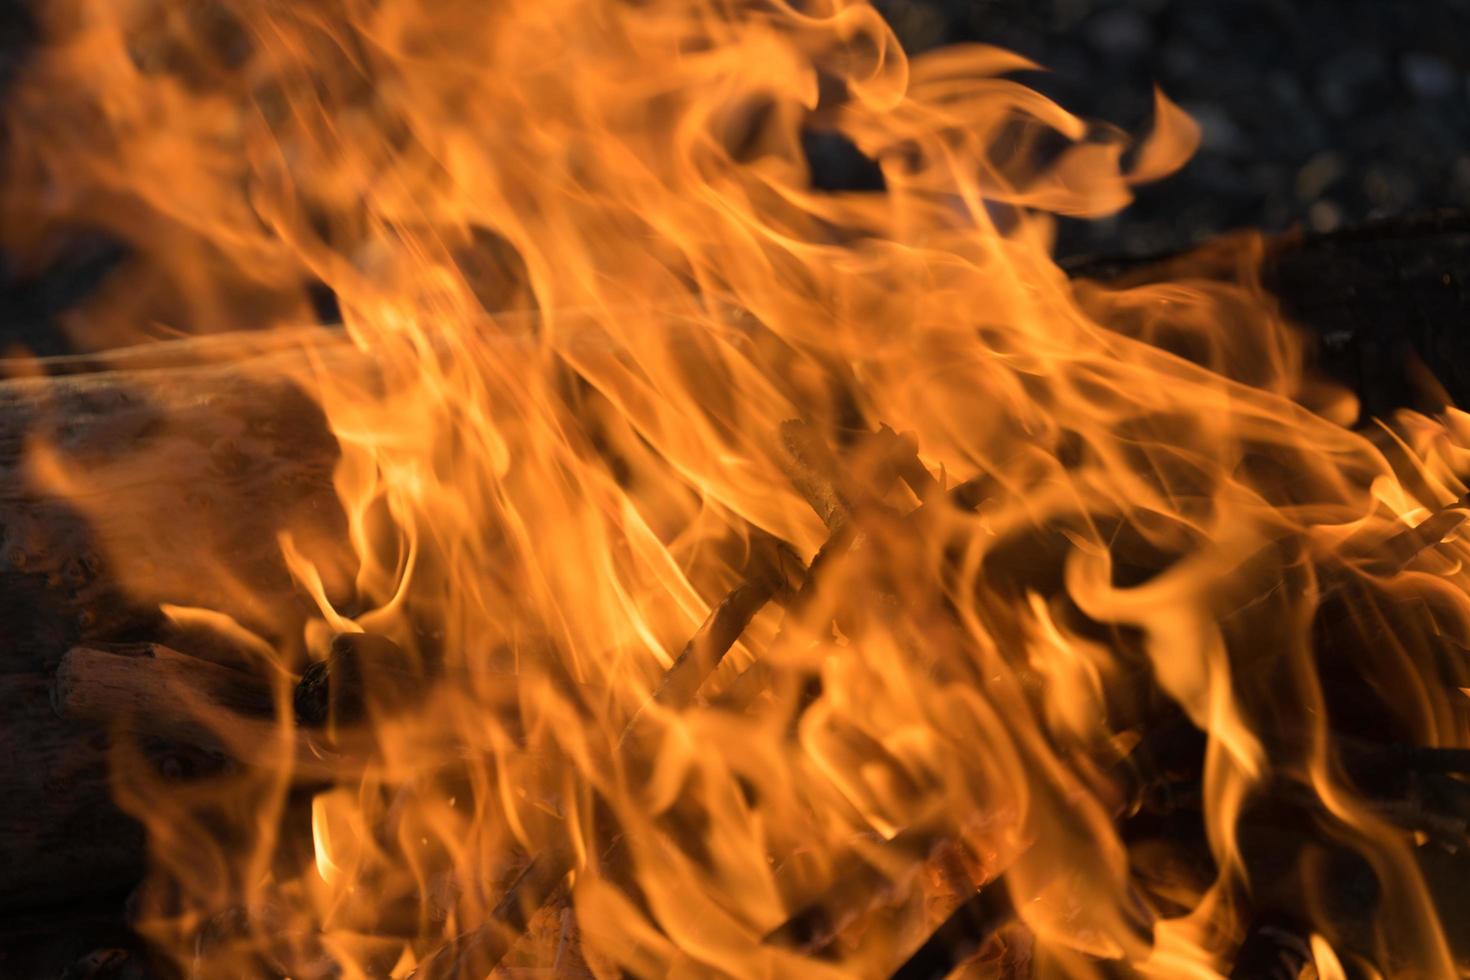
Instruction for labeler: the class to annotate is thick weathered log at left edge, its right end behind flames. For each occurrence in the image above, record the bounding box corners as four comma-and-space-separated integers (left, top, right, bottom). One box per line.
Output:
0, 327, 344, 673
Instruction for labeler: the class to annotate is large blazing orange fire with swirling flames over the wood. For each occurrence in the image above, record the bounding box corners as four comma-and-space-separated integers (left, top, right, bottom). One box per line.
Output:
4, 0, 1470, 977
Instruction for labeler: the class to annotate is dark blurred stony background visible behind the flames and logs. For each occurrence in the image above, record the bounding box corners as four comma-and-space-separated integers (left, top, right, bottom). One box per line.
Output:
0, 0, 1470, 356
